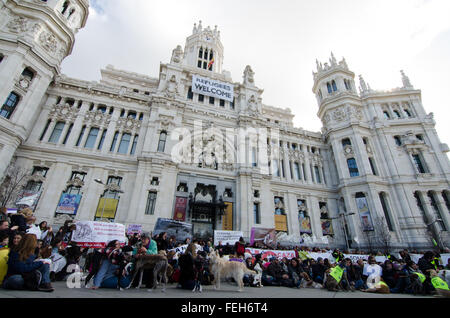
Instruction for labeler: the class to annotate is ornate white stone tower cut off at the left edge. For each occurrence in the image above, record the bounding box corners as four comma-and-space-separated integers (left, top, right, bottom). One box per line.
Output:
0, 0, 89, 178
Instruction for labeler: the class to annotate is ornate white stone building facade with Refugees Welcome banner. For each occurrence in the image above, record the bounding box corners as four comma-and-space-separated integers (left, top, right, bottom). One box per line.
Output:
0, 0, 450, 249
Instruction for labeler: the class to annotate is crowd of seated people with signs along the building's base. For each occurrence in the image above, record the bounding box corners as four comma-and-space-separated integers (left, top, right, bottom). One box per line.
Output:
0, 209, 450, 295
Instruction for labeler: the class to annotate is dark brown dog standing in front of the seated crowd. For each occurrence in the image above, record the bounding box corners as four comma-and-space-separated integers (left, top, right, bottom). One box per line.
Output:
125, 254, 169, 293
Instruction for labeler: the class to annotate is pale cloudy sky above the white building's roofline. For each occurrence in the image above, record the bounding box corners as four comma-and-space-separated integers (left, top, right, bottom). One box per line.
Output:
62, 0, 450, 144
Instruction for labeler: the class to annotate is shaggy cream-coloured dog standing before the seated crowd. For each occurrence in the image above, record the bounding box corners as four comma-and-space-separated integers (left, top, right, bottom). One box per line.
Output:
209, 251, 258, 292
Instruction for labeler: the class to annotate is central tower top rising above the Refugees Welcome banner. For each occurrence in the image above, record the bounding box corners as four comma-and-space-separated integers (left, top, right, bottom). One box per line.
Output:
184, 21, 223, 73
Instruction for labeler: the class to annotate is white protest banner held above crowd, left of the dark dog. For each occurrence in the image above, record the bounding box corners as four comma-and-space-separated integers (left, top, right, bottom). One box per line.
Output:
72, 221, 126, 248
